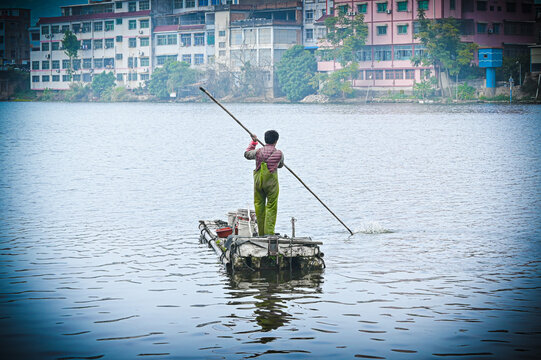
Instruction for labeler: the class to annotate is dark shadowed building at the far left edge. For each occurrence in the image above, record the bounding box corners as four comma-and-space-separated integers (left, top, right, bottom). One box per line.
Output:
0, 9, 30, 66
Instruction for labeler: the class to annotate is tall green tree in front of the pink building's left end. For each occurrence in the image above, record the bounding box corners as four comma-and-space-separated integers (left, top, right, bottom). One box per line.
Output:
325, 12, 368, 66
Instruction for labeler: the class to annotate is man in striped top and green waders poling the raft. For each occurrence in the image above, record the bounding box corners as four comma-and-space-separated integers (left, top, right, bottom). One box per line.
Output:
244, 130, 284, 236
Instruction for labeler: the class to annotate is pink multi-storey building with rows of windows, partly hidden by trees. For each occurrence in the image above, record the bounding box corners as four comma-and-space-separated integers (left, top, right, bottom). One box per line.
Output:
318, 0, 536, 88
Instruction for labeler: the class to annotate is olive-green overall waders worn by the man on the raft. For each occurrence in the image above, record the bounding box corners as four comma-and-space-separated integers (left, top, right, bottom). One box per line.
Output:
254, 163, 280, 236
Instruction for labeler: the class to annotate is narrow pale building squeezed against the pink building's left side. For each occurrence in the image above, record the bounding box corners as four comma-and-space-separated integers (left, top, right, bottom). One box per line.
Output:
302, 0, 333, 50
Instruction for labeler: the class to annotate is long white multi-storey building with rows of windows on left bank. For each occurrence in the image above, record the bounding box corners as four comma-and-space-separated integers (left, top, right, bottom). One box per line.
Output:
31, 0, 154, 90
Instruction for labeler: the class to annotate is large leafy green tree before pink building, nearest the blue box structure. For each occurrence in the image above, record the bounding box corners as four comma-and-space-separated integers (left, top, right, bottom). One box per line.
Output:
411, 9, 478, 94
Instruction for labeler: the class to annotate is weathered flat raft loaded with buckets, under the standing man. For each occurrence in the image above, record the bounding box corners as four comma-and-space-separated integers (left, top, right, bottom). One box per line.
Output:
199, 210, 325, 271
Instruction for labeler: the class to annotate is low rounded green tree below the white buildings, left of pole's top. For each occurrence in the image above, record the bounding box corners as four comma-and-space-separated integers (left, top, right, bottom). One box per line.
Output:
147, 61, 198, 99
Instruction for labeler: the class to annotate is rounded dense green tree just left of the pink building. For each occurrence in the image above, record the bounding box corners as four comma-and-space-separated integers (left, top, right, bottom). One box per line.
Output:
276, 45, 317, 101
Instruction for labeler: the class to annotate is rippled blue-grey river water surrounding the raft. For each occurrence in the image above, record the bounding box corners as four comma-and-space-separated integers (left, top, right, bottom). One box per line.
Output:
0, 103, 541, 359
